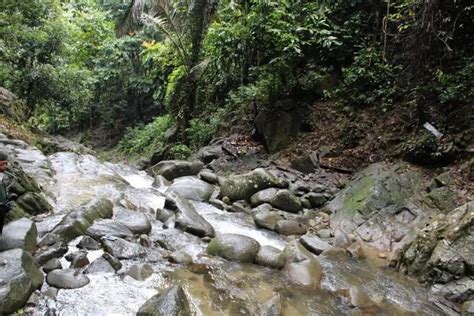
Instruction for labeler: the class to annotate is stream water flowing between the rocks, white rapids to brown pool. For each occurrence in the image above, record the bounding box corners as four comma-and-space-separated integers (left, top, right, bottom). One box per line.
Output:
3, 148, 448, 316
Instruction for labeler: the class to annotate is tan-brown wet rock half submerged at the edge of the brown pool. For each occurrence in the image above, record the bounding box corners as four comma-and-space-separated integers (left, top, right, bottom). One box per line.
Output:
282, 241, 323, 289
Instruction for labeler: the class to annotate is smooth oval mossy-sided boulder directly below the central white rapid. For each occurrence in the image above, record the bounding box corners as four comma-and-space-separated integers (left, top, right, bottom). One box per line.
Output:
207, 234, 260, 262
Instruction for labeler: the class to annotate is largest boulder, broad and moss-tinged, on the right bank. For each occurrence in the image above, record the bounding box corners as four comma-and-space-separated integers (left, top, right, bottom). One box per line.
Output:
324, 163, 426, 251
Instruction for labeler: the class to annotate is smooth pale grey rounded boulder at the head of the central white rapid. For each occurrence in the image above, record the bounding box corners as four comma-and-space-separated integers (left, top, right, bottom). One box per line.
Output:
166, 177, 214, 201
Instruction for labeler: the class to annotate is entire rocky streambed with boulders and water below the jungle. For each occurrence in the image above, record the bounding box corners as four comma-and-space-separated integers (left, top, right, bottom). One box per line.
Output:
0, 135, 474, 315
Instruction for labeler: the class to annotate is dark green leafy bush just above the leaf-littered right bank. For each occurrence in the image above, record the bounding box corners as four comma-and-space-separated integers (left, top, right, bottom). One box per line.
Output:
340, 47, 401, 106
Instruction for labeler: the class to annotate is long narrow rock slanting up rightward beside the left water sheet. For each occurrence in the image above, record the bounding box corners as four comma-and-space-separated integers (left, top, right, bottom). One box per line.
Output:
53, 199, 113, 242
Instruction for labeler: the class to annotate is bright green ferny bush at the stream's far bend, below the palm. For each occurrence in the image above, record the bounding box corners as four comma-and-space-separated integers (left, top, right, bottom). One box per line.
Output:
119, 115, 172, 156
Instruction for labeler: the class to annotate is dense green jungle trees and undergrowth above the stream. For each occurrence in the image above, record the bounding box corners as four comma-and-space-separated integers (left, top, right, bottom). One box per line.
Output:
0, 0, 474, 165
